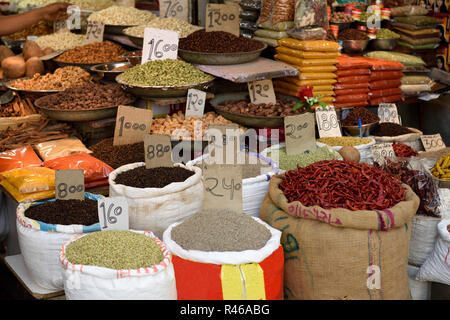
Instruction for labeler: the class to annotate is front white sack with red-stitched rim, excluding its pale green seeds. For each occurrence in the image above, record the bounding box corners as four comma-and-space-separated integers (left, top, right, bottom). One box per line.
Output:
59, 230, 177, 300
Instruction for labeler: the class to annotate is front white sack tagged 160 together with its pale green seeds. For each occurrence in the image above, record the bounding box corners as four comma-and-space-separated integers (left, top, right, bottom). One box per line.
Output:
59, 230, 177, 300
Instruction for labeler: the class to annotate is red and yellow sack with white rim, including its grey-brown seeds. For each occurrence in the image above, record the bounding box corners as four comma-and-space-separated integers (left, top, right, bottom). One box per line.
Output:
163, 209, 284, 300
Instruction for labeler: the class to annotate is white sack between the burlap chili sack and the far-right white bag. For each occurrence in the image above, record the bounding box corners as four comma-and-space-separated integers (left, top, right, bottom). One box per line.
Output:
408, 214, 441, 267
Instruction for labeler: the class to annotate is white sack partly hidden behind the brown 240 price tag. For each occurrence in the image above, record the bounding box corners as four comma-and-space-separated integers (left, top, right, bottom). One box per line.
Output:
187, 152, 278, 217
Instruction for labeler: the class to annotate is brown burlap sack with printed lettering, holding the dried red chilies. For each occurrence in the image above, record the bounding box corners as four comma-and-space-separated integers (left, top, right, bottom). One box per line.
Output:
260, 174, 419, 300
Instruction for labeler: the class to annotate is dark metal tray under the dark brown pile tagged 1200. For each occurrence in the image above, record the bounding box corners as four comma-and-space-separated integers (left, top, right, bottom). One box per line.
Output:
178, 44, 267, 65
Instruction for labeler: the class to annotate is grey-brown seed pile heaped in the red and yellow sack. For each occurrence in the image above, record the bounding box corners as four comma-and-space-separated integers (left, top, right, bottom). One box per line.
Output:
171, 209, 271, 252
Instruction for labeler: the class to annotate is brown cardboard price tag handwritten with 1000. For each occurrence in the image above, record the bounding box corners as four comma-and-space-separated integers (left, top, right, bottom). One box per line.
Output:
113, 106, 153, 146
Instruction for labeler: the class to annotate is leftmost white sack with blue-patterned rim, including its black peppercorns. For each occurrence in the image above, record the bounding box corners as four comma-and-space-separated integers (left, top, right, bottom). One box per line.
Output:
16, 192, 103, 291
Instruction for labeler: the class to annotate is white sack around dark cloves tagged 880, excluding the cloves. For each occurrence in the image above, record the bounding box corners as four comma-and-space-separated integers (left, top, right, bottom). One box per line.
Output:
108, 162, 203, 238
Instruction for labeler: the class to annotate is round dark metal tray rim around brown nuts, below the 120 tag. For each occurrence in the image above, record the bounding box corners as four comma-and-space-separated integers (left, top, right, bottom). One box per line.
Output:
210, 92, 300, 128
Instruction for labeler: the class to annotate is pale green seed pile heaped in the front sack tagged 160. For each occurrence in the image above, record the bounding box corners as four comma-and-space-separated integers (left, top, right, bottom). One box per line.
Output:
65, 230, 164, 270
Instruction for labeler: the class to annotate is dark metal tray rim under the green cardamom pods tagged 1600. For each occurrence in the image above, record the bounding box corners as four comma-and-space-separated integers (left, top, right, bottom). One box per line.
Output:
116, 74, 214, 99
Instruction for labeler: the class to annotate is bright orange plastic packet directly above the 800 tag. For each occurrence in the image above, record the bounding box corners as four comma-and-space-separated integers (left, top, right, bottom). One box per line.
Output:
44, 152, 114, 188
